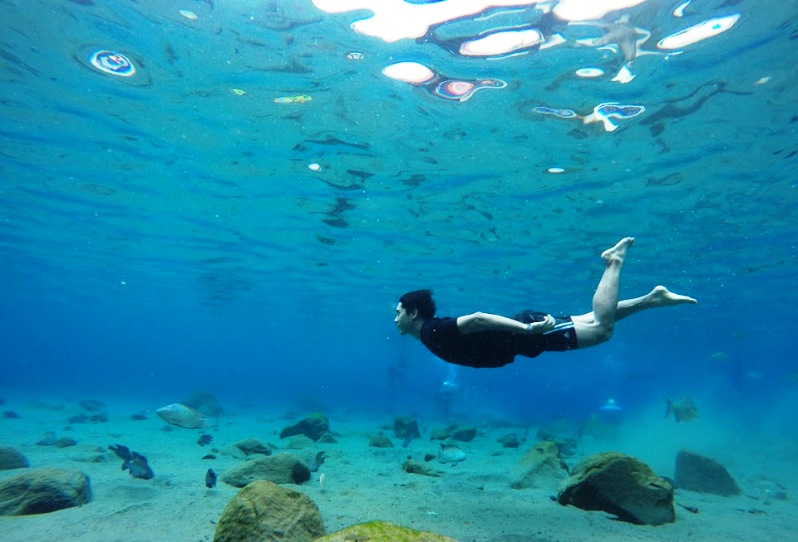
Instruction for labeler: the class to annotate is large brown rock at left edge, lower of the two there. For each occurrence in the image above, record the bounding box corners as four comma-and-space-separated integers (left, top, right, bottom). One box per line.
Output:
0, 469, 91, 516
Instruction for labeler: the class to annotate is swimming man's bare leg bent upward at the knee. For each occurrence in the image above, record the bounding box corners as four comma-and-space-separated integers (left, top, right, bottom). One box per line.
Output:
574, 237, 635, 348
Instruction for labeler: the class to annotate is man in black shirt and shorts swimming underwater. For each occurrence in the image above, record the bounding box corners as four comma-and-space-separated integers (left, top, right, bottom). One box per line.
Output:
394, 237, 697, 367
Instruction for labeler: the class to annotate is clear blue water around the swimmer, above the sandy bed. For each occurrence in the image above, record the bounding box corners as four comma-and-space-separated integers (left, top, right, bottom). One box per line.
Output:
0, 0, 798, 437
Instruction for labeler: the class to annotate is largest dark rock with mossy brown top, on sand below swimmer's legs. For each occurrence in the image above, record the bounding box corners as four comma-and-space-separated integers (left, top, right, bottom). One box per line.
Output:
557, 452, 676, 525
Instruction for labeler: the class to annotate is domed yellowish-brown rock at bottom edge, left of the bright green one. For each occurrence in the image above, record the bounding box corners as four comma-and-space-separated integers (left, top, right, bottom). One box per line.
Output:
213, 481, 325, 542
